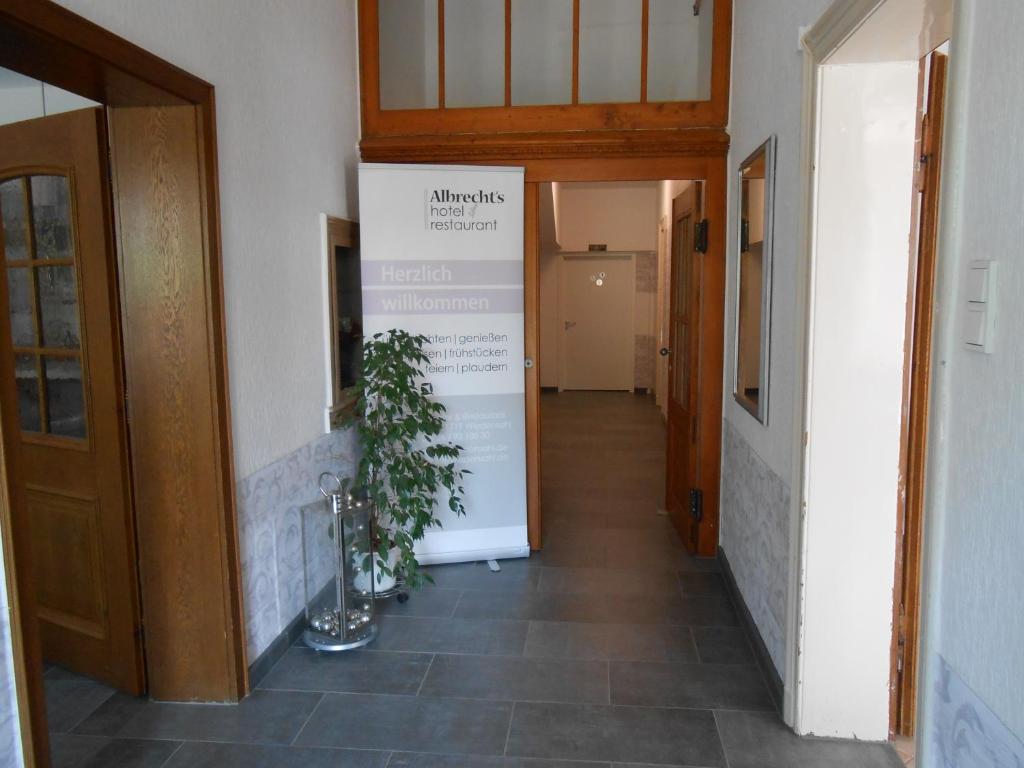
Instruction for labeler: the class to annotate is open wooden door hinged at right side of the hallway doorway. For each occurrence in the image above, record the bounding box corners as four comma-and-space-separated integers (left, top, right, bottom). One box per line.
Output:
666, 188, 701, 552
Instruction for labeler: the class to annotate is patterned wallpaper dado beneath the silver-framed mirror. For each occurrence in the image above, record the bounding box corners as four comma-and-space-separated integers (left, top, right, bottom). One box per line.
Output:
721, 420, 790, 680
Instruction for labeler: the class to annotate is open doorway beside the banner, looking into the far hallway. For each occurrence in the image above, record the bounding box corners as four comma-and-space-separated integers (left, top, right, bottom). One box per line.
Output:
539, 181, 701, 567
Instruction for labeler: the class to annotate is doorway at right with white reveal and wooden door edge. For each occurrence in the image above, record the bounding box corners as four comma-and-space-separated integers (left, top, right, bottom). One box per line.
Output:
786, 3, 952, 745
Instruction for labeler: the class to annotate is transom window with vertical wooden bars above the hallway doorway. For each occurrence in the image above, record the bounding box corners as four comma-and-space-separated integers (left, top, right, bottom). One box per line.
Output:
378, 0, 715, 110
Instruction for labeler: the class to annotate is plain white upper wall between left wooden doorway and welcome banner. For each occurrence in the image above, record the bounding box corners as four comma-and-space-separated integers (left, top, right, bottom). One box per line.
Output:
52, 0, 358, 479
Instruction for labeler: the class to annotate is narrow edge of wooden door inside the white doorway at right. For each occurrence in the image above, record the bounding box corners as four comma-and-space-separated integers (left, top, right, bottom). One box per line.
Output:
892, 52, 948, 736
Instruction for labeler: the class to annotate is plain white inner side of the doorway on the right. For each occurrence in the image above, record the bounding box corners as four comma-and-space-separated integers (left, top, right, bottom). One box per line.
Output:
797, 61, 919, 739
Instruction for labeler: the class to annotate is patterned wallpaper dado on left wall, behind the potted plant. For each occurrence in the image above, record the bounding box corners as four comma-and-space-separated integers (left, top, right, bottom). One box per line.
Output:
237, 429, 356, 664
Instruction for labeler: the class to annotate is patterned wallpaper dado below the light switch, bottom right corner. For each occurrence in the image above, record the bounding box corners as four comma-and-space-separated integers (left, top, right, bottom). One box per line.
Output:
930, 654, 1024, 768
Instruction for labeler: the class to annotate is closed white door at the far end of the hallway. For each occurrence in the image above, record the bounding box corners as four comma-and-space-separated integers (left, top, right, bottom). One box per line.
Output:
558, 253, 636, 391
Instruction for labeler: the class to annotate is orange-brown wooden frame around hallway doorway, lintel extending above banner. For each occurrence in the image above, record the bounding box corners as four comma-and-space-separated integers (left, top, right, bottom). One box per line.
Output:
359, 137, 729, 550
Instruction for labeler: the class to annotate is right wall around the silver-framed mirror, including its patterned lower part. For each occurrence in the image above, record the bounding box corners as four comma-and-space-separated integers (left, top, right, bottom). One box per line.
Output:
720, 0, 830, 678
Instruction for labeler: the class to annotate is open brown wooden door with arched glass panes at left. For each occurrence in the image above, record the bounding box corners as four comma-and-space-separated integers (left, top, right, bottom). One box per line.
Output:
0, 110, 144, 694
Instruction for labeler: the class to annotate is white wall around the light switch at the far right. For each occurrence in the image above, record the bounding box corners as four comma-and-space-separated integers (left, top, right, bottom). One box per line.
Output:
921, 0, 1024, 766
